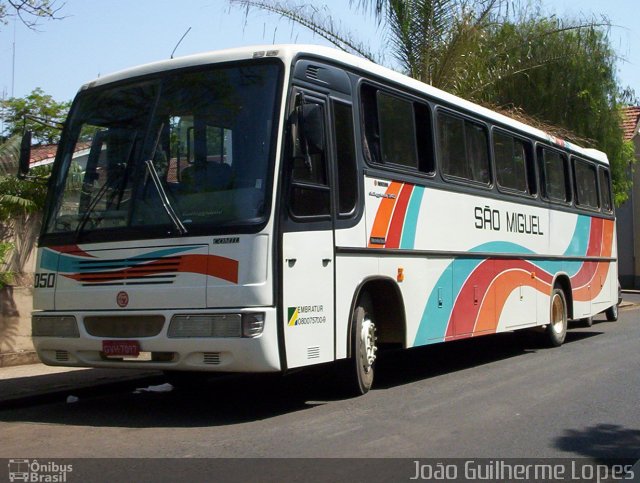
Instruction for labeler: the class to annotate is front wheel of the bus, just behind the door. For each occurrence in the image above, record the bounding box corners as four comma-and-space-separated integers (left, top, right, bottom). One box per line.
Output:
342, 297, 378, 396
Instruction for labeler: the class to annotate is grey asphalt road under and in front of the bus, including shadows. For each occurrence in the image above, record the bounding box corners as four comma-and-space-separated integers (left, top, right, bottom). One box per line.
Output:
0, 308, 640, 466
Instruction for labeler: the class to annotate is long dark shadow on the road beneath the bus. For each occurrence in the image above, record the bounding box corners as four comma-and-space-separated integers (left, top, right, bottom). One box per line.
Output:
0, 329, 601, 428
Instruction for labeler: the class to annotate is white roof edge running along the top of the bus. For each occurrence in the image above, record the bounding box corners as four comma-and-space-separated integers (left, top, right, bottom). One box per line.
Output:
81, 44, 609, 164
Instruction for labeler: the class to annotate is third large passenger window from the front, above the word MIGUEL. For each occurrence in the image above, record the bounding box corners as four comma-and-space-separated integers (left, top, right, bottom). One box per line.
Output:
493, 132, 529, 194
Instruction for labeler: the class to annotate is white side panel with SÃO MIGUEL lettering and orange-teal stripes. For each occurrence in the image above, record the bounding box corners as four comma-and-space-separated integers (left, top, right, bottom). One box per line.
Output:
366, 178, 614, 346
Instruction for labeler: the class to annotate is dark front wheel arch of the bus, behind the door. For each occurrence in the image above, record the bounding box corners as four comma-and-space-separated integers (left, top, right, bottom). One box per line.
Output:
347, 277, 407, 357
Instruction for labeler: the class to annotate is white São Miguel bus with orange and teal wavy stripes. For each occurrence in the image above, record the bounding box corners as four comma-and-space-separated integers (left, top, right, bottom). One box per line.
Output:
21, 45, 618, 395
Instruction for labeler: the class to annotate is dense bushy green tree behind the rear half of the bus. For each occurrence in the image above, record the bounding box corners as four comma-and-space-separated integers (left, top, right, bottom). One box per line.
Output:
468, 13, 634, 205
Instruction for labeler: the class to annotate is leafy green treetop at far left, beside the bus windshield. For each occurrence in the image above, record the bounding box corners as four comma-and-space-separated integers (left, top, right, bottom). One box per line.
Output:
0, 87, 71, 144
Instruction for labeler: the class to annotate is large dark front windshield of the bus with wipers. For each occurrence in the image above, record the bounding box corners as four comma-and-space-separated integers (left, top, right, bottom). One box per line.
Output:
43, 63, 280, 242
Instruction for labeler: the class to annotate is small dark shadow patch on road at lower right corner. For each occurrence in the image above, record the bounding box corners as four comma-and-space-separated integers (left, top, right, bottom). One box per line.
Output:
554, 424, 640, 464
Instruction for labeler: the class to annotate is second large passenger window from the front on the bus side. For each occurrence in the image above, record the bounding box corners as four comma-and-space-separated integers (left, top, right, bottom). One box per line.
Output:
438, 112, 491, 185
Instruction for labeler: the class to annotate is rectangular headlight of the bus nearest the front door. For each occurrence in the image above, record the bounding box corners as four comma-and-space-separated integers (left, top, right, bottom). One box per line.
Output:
167, 313, 264, 339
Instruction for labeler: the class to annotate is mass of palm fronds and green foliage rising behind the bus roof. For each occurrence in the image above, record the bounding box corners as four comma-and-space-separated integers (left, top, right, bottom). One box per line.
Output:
229, 0, 633, 204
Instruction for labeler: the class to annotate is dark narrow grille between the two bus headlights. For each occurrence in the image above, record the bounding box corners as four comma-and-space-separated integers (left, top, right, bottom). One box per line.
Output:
84, 315, 164, 339
